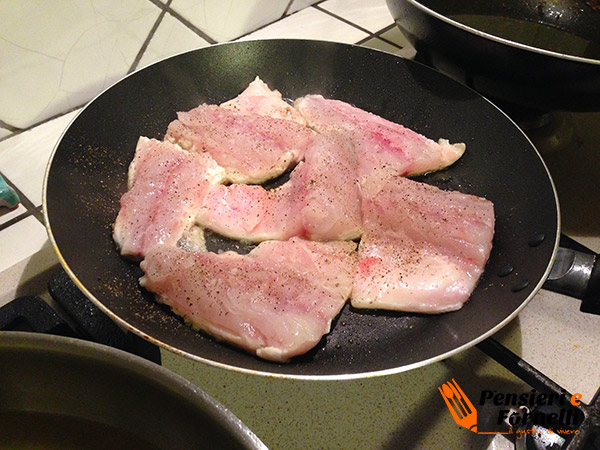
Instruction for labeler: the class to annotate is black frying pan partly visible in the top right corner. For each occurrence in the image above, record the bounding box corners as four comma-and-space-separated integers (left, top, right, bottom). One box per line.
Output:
387, 0, 600, 111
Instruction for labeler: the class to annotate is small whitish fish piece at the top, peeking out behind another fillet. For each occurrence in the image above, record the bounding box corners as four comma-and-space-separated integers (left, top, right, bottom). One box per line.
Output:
220, 77, 306, 125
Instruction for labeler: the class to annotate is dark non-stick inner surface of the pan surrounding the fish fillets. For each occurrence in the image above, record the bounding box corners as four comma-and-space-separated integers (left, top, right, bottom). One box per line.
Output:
44, 40, 559, 379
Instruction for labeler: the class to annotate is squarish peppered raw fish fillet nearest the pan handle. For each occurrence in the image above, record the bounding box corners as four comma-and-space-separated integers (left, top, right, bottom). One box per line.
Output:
352, 175, 494, 313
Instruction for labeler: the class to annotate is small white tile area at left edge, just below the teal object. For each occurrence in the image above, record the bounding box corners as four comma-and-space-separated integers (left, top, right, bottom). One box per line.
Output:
0, 216, 50, 272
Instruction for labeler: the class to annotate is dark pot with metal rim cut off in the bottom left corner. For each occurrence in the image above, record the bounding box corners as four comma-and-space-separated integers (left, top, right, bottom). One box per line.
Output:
0, 332, 266, 450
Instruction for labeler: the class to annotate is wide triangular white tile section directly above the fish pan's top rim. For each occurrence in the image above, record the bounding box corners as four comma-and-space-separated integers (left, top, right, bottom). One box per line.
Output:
237, 8, 368, 44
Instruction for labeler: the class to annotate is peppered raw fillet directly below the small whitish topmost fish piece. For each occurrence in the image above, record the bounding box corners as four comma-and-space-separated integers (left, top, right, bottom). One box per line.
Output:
165, 105, 314, 184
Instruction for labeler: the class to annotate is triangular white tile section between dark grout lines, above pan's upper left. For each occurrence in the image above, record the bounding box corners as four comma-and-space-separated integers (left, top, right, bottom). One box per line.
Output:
138, 14, 210, 68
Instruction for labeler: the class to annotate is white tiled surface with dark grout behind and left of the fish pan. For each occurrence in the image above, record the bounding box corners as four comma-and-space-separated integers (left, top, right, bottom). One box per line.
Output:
0, 0, 412, 274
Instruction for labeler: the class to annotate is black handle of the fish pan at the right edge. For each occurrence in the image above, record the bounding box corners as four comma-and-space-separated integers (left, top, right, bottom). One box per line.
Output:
543, 236, 600, 314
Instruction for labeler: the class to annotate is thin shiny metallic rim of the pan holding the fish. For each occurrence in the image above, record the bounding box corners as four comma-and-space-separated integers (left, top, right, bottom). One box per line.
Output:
42, 39, 561, 381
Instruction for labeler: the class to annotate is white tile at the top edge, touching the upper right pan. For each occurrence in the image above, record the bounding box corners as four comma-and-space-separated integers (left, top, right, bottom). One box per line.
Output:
319, 0, 394, 33
